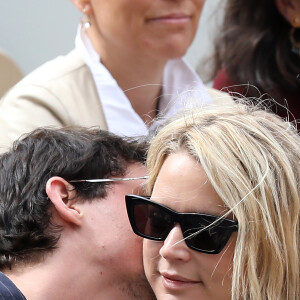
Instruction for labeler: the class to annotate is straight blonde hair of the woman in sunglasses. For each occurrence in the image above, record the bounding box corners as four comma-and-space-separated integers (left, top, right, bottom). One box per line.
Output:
147, 104, 300, 300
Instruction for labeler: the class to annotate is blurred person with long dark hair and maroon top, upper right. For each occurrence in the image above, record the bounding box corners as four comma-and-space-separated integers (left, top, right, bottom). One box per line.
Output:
212, 0, 300, 120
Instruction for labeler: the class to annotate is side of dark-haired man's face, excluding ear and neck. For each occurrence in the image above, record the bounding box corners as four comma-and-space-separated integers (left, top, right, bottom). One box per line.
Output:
72, 164, 152, 300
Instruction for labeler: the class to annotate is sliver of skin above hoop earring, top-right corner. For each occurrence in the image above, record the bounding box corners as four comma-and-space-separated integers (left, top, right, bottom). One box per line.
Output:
275, 0, 300, 28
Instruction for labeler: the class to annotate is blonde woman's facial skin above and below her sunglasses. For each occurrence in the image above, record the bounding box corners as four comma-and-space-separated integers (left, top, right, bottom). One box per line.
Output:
143, 152, 236, 300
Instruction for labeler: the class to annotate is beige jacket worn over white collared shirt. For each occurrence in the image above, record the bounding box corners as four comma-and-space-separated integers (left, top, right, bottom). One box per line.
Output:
0, 50, 232, 152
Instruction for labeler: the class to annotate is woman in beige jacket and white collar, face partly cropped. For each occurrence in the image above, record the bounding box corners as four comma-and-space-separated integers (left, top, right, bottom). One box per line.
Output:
0, 0, 230, 150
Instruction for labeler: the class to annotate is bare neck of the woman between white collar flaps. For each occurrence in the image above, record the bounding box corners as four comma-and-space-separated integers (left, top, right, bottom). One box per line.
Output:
88, 27, 166, 123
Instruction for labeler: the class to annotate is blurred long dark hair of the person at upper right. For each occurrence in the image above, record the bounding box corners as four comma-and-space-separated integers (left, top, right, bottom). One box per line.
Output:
212, 0, 300, 92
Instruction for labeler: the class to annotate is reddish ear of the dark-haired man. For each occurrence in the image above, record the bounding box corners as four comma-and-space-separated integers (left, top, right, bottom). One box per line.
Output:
46, 176, 82, 226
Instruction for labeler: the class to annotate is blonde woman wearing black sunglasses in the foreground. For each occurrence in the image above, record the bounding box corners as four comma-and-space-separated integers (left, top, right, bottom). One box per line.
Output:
126, 104, 300, 300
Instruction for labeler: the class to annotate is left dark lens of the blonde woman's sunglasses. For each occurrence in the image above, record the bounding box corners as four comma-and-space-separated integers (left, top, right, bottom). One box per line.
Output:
133, 203, 173, 240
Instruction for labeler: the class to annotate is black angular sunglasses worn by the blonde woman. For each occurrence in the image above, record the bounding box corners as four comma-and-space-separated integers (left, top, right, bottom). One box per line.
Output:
125, 195, 238, 254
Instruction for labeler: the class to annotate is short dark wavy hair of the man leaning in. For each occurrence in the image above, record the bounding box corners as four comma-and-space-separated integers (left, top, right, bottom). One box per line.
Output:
0, 128, 147, 270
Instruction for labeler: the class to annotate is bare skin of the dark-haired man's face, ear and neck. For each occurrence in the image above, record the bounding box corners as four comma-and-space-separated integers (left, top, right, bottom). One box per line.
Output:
6, 163, 155, 300
